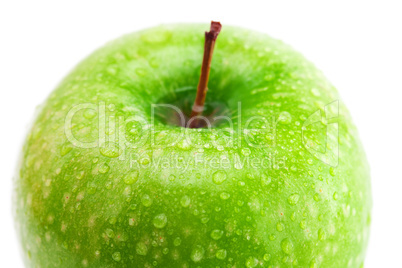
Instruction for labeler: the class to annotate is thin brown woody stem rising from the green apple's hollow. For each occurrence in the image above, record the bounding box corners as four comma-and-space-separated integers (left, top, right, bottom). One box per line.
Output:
189, 21, 222, 128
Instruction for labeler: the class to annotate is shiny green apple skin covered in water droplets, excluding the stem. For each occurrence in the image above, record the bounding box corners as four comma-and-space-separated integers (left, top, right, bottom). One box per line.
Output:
14, 24, 372, 268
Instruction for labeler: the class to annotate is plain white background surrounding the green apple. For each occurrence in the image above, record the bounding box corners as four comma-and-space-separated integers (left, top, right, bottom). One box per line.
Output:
0, 0, 402, 268
